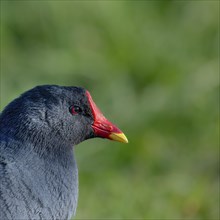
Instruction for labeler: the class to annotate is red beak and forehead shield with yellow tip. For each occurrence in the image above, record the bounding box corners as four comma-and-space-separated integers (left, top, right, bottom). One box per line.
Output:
86, 91, 128, 143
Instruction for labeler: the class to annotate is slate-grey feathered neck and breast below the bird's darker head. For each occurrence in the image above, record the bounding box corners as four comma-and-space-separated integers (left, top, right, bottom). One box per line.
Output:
0, 137, 78, 219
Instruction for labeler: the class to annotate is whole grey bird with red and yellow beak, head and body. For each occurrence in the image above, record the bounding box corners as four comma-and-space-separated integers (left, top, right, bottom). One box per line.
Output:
0, 85, 128, 219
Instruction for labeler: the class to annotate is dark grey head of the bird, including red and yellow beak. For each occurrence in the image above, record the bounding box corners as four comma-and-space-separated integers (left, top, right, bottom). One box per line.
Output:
0, 85, 128, 145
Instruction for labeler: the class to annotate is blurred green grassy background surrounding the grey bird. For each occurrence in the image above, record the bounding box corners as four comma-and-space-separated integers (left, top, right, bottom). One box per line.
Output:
1, 1, 219, 220
